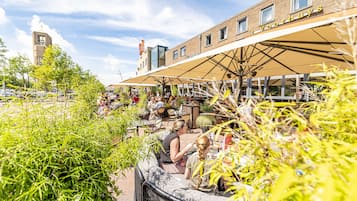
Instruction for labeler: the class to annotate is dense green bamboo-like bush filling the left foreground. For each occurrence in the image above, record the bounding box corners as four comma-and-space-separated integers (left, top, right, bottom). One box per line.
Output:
0, 95, 156, 200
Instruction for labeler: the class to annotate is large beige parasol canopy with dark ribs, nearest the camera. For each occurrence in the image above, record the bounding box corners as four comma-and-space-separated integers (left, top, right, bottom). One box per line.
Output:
121, 8, 357, 83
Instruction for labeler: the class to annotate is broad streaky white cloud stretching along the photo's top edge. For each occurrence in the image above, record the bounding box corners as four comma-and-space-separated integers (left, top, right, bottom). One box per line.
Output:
5, 0, 214, 38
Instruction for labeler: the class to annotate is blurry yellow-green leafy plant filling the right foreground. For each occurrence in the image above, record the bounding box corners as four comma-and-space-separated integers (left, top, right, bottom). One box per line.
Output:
204, 69, 357, 200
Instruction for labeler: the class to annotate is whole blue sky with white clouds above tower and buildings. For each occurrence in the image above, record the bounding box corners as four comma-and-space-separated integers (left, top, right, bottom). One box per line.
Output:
0, 0, 260, 85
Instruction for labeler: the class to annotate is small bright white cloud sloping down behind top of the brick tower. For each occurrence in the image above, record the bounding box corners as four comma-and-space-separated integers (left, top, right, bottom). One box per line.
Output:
31, 15, 76, 53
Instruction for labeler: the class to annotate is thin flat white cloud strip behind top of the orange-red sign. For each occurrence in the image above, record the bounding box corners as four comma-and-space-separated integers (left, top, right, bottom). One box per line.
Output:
88, 36, 169, 48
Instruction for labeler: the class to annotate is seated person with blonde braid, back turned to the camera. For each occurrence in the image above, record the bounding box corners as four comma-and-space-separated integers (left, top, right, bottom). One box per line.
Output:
185, 135, 216, 192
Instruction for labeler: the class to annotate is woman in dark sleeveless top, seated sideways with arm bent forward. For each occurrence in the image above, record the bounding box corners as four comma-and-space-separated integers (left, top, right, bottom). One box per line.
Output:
160, 120, 193, 174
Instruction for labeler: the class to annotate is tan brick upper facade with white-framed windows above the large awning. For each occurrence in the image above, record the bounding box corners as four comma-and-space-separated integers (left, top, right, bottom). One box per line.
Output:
166, 0, 357, 66
